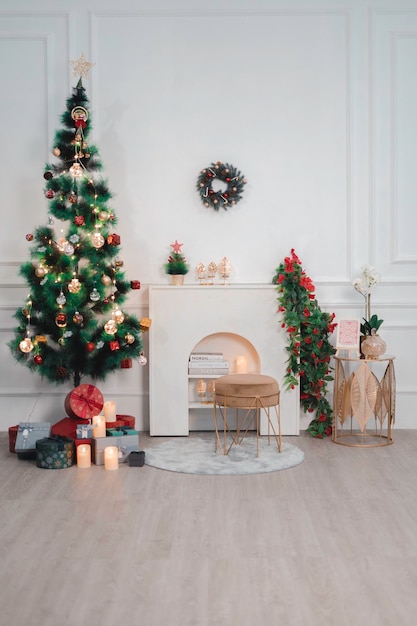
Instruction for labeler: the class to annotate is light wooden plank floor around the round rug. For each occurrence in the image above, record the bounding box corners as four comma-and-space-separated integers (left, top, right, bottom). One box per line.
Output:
0, 430, 417, 626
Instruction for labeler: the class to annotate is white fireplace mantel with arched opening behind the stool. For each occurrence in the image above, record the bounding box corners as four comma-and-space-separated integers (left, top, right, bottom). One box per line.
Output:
149, 284, 300, 436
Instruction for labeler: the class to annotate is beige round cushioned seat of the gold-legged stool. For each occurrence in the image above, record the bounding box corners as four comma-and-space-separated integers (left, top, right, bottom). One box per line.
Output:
214, 374, 279, 409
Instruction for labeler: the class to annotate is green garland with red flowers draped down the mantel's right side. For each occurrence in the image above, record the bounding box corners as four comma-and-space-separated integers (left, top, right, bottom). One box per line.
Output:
272, 249, 336, 439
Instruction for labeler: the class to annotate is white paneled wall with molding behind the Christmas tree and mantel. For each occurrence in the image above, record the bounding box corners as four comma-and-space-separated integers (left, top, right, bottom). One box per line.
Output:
0, 0, 417, 430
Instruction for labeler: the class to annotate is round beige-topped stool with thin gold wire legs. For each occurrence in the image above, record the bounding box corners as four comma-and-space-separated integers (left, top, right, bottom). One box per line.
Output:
214, 374, 282, 456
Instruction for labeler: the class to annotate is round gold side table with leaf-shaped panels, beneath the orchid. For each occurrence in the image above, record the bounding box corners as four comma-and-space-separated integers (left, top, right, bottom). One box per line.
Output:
332, 355, 396, 448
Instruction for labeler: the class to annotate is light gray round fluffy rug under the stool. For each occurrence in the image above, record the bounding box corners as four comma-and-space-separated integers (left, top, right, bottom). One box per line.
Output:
145, 433, 304, 475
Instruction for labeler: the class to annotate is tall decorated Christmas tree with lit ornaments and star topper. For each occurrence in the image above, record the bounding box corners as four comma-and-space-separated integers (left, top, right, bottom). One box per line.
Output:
9, 56, 145, 386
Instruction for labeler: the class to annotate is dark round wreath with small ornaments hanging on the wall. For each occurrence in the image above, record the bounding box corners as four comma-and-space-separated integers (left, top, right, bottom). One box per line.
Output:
197, 161, 246, 211
